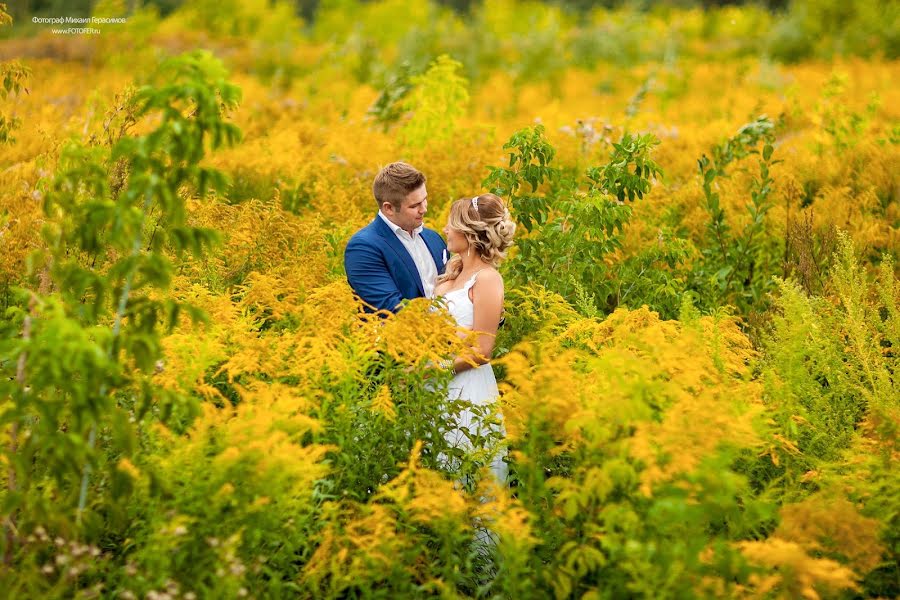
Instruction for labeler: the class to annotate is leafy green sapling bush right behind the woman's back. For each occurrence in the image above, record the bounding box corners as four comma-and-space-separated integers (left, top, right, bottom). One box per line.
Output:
483, 125, 682, 314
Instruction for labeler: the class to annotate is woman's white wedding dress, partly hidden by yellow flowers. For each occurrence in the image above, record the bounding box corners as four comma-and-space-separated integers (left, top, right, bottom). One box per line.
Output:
442, 271, 507, 483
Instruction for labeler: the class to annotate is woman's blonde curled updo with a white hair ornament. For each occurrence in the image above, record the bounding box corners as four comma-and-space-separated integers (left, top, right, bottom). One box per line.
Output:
438, 194, 516, 282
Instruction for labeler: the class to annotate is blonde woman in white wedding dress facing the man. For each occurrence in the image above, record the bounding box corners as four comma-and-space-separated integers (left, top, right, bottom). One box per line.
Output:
435, 194, 516, 482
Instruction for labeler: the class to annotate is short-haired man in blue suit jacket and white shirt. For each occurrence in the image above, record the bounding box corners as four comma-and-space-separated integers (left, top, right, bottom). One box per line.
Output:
344, 162, 447, 312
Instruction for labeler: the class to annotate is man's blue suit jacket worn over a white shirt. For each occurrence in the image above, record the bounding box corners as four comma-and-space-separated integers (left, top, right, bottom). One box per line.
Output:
344, 216, 447, 311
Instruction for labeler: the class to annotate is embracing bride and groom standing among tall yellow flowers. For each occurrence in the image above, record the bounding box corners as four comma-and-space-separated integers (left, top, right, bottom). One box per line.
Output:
344, 162, 516, 481
